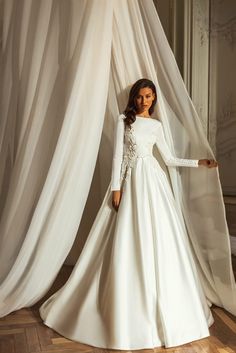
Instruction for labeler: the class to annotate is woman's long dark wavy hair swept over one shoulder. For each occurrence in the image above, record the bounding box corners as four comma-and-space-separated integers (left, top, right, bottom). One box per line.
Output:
123, 78, 157, 126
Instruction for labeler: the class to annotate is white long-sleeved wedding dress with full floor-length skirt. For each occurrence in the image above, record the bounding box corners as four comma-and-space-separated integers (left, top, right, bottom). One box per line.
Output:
40, 114, 214, 350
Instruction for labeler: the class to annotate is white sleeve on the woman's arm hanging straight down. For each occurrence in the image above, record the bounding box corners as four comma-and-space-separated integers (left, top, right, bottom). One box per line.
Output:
111, 114, 124, 190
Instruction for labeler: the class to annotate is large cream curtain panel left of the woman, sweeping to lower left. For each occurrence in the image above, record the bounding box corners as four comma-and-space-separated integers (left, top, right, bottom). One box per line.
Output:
0, 0, 113, 316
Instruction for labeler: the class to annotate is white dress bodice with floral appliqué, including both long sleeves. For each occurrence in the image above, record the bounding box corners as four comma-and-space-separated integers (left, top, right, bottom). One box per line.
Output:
111, 114, 198, 190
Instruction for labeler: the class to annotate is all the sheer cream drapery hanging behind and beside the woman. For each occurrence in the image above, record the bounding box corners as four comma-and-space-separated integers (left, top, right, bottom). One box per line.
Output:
0, 0, 236, 316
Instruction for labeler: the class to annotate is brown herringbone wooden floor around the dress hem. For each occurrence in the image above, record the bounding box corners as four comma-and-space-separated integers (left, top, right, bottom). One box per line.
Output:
0, 256, 236, 353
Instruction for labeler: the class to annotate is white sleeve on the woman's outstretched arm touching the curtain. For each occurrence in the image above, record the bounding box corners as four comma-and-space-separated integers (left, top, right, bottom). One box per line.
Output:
156, 123, 199, 167
